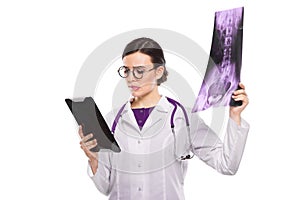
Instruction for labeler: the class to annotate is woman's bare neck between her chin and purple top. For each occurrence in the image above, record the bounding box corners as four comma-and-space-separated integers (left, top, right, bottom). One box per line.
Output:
131, 87, 161, 108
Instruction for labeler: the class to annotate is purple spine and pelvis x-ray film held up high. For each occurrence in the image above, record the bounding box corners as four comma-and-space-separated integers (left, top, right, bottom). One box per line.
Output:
192, 7, 244, 112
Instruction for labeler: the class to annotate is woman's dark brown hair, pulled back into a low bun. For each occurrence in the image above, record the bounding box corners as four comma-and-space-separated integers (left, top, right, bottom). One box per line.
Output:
122, 37, 168, 85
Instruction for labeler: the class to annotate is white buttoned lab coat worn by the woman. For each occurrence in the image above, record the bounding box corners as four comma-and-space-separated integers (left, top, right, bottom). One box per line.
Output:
89, 96, 249, 200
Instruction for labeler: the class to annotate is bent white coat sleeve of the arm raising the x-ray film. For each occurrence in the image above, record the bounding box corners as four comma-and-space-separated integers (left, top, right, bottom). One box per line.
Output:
191, 114, 249, 175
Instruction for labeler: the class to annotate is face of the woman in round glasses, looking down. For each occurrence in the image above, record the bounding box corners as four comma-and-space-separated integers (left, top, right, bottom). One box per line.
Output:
123, 52, 157, 97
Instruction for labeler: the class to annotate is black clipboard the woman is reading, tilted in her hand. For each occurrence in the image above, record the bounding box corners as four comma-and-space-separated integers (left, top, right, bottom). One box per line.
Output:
65, 97, 121, 152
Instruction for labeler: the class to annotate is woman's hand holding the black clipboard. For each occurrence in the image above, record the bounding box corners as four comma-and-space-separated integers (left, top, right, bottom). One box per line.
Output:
78, 125, 98, 174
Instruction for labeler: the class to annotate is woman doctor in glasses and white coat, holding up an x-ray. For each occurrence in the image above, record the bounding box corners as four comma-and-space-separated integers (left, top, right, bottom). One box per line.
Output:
79, 38, 249, 200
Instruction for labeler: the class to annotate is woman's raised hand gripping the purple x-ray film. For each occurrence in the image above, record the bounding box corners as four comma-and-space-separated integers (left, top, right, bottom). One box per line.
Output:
229, 83, 249, 125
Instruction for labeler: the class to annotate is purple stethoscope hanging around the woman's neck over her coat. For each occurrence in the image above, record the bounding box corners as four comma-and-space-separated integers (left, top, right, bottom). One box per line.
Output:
111, 97, 195, 160
